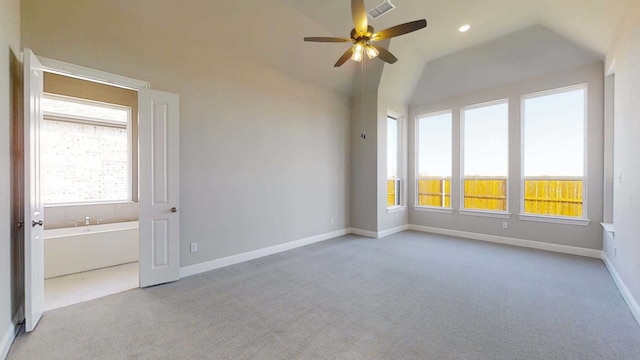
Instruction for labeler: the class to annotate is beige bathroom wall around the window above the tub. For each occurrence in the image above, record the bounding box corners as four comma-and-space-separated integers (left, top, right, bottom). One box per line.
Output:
44, 73, 138, 229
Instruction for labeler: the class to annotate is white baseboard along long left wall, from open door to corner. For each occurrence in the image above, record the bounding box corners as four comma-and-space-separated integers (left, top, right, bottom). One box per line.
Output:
180, 229, 351, 278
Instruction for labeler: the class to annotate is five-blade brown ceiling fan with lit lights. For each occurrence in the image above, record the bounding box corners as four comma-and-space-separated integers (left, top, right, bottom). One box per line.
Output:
304, 0, 427, 67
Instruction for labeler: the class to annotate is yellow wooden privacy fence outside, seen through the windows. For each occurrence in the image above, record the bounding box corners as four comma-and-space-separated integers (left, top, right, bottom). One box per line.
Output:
408, 177, 583, 217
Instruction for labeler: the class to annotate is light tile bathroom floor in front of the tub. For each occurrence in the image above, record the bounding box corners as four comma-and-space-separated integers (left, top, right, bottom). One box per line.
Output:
44, 262, 139, 310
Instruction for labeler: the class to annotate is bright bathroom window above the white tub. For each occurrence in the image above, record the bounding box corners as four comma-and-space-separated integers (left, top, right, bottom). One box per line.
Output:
40, 94, 131, 204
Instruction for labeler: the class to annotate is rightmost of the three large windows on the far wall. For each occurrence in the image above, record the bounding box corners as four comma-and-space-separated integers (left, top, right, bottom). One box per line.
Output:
523, 86, 587, 217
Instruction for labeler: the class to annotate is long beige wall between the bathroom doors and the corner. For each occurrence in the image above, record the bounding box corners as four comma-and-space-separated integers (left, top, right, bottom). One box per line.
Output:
22, 0, 350, 266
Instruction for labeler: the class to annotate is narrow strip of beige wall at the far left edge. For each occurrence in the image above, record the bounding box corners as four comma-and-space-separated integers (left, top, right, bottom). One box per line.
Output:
0, 0, 21, 357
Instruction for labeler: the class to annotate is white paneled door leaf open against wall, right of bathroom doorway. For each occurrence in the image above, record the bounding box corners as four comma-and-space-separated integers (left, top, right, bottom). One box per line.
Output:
138, 89, 180, 287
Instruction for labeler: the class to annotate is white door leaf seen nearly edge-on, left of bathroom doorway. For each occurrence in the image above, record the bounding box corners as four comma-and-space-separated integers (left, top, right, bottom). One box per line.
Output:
23, 49, 44, 331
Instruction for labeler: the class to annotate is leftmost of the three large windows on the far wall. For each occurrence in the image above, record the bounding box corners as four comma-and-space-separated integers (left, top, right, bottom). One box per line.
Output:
416, 111, 452, 208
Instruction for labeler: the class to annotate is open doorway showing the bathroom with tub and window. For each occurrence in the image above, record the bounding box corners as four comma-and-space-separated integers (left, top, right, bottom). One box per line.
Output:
40, 72, 139, 310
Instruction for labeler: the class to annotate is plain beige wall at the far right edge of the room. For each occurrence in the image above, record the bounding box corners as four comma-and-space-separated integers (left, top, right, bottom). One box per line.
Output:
604, 1, 640, 320
